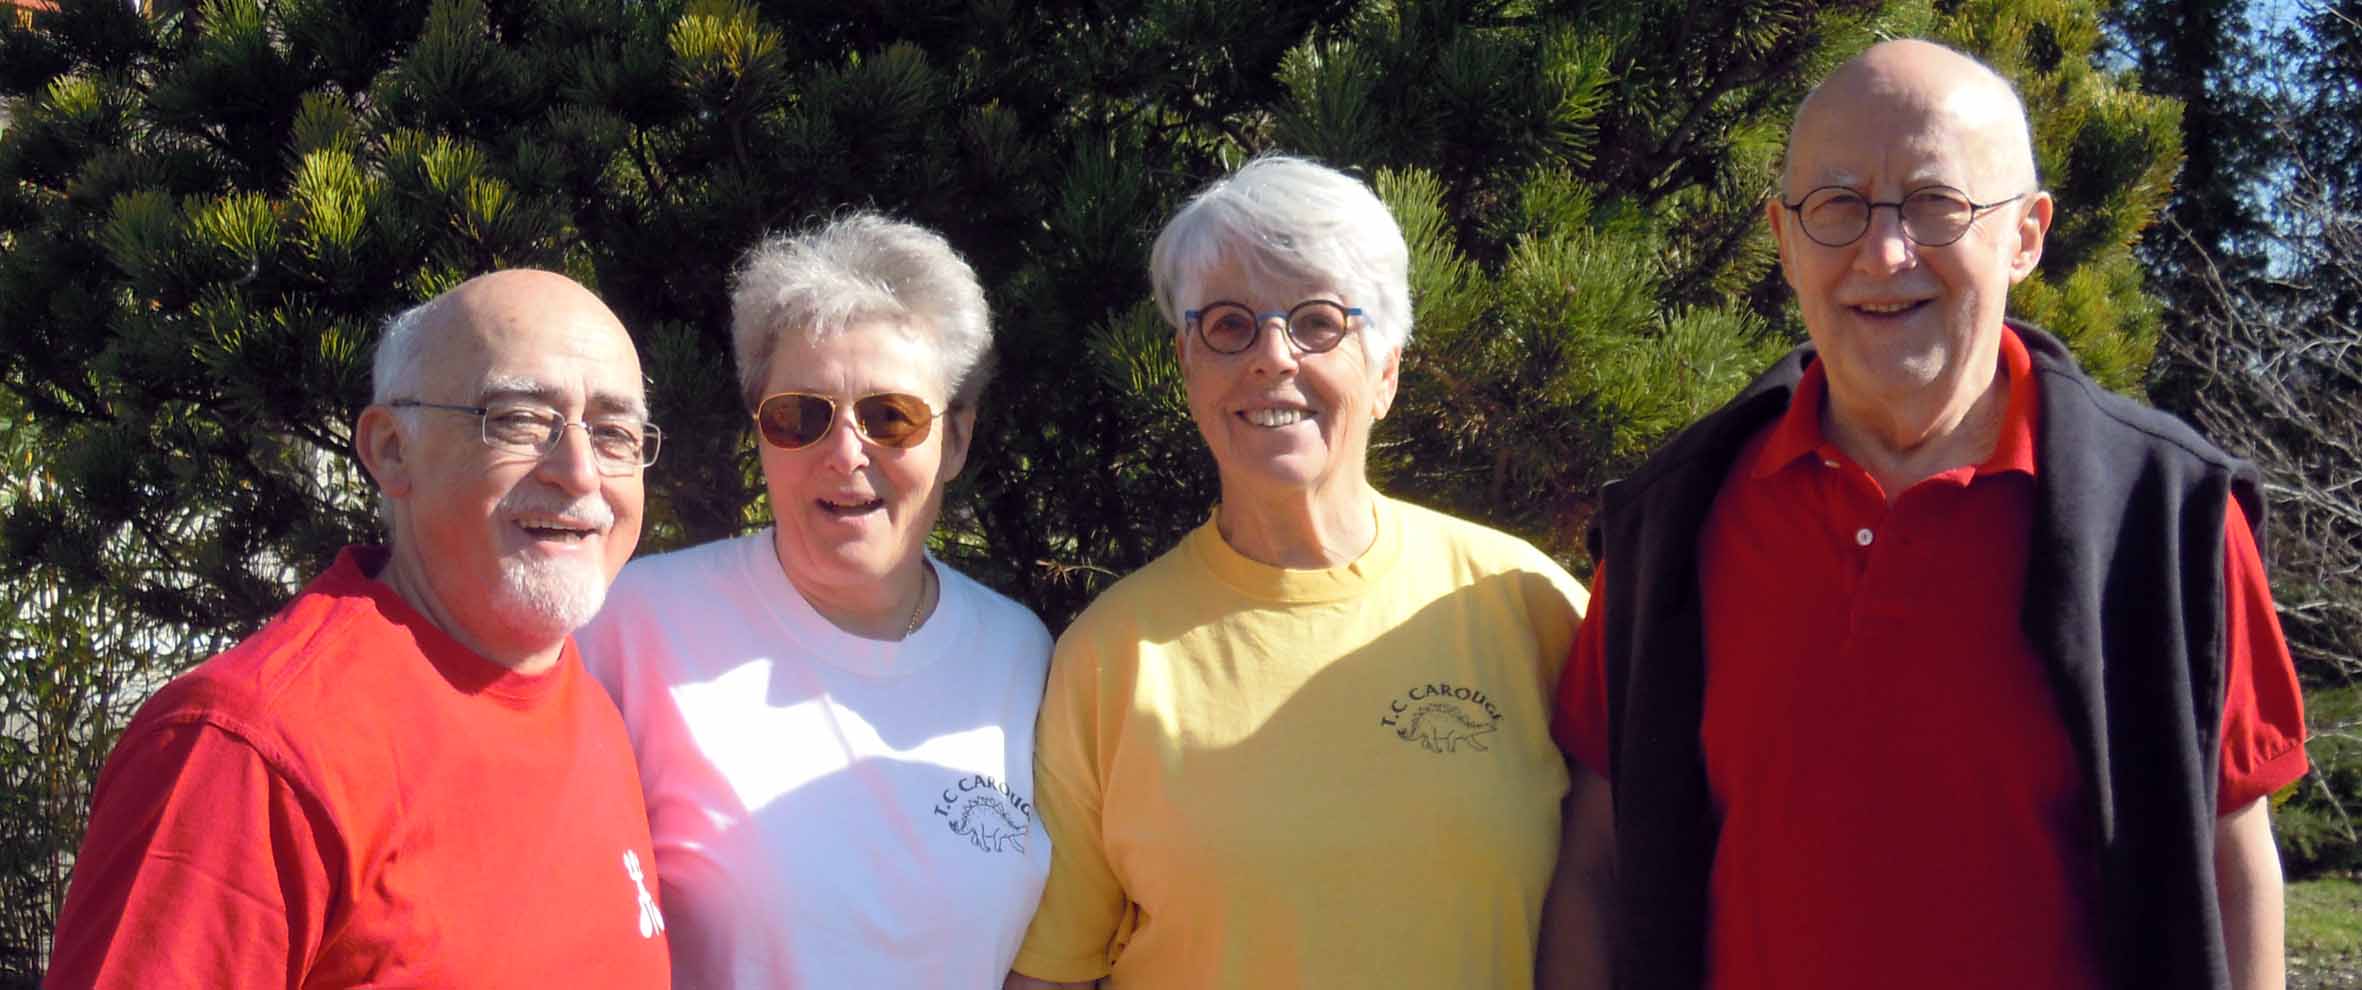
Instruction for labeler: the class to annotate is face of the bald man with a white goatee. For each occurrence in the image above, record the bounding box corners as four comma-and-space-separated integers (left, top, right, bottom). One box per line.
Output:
357, 272, 647, 662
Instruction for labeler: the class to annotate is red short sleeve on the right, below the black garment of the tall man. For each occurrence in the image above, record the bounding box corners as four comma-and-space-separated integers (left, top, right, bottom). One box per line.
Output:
2216, 499, 2308, 815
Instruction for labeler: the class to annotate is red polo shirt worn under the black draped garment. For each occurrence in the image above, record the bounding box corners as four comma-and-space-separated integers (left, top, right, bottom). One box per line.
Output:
1554, 333, 2305, 990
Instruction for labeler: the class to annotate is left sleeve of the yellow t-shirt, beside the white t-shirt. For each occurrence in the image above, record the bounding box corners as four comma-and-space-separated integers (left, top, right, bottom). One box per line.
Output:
1013, 628, 1129, 983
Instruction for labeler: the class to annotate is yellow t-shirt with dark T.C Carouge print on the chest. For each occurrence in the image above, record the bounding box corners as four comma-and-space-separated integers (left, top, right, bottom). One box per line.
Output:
1016, 499, 1587, 990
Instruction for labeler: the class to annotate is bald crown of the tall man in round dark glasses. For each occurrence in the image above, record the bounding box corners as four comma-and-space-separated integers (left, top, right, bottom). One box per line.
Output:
1781, 40, 2036, 198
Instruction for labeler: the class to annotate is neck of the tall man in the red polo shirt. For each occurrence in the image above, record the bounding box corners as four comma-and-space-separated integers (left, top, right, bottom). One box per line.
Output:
1821, 357, 2010, 503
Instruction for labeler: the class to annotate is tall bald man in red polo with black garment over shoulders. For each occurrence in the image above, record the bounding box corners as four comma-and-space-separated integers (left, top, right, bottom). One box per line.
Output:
1542, 40, 2305, 990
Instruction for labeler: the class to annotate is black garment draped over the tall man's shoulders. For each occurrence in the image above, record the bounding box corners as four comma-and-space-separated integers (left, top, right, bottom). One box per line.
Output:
1590, 324, 2263, 990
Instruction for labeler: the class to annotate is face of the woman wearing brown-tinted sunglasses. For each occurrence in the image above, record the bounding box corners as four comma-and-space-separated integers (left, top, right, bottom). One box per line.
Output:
758, 321, 976, 607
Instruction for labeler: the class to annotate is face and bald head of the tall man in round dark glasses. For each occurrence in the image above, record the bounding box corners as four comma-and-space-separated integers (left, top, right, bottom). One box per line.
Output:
1767, 43, 2050, 422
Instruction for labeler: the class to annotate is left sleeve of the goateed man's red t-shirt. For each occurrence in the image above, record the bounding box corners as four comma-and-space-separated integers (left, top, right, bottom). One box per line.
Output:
47, 721, 340, 988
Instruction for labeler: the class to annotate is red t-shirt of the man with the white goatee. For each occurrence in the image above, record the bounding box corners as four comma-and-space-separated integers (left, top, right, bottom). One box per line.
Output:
47, 548, 668, 990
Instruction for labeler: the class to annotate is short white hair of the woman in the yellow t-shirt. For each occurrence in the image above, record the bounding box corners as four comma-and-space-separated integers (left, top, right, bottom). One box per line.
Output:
1148, 154, 1410, 356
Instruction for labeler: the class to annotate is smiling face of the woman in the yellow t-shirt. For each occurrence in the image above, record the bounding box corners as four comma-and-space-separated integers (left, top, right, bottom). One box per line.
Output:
1174, 262, 1401, 503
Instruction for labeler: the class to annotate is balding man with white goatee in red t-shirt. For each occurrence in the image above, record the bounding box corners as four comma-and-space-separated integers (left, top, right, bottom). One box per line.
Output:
45, 272, 671, 990
